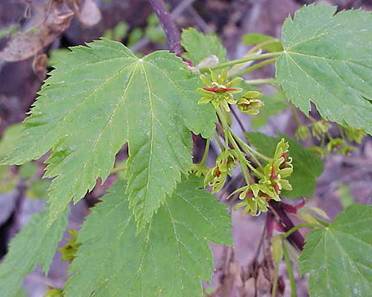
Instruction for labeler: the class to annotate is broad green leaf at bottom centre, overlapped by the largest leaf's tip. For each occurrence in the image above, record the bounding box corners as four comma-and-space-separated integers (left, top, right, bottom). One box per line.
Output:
65, 178, 231, 297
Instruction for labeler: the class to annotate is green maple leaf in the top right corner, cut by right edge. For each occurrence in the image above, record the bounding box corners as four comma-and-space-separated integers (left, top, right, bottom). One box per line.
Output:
276, 5, 372, 134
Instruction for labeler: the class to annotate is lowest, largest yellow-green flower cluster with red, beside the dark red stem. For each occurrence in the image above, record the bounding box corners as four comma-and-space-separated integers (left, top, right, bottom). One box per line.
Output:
237, 139, 293, 215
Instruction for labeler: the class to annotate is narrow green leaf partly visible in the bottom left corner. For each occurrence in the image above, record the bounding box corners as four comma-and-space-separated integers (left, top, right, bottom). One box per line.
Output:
0, 211, 67, 297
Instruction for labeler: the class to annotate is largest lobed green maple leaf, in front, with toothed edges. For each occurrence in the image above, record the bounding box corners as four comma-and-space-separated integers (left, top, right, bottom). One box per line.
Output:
0, 40, 215, 225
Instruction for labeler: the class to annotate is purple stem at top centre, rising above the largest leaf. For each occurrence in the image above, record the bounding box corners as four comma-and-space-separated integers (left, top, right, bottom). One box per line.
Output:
148, 0, 182, 56
